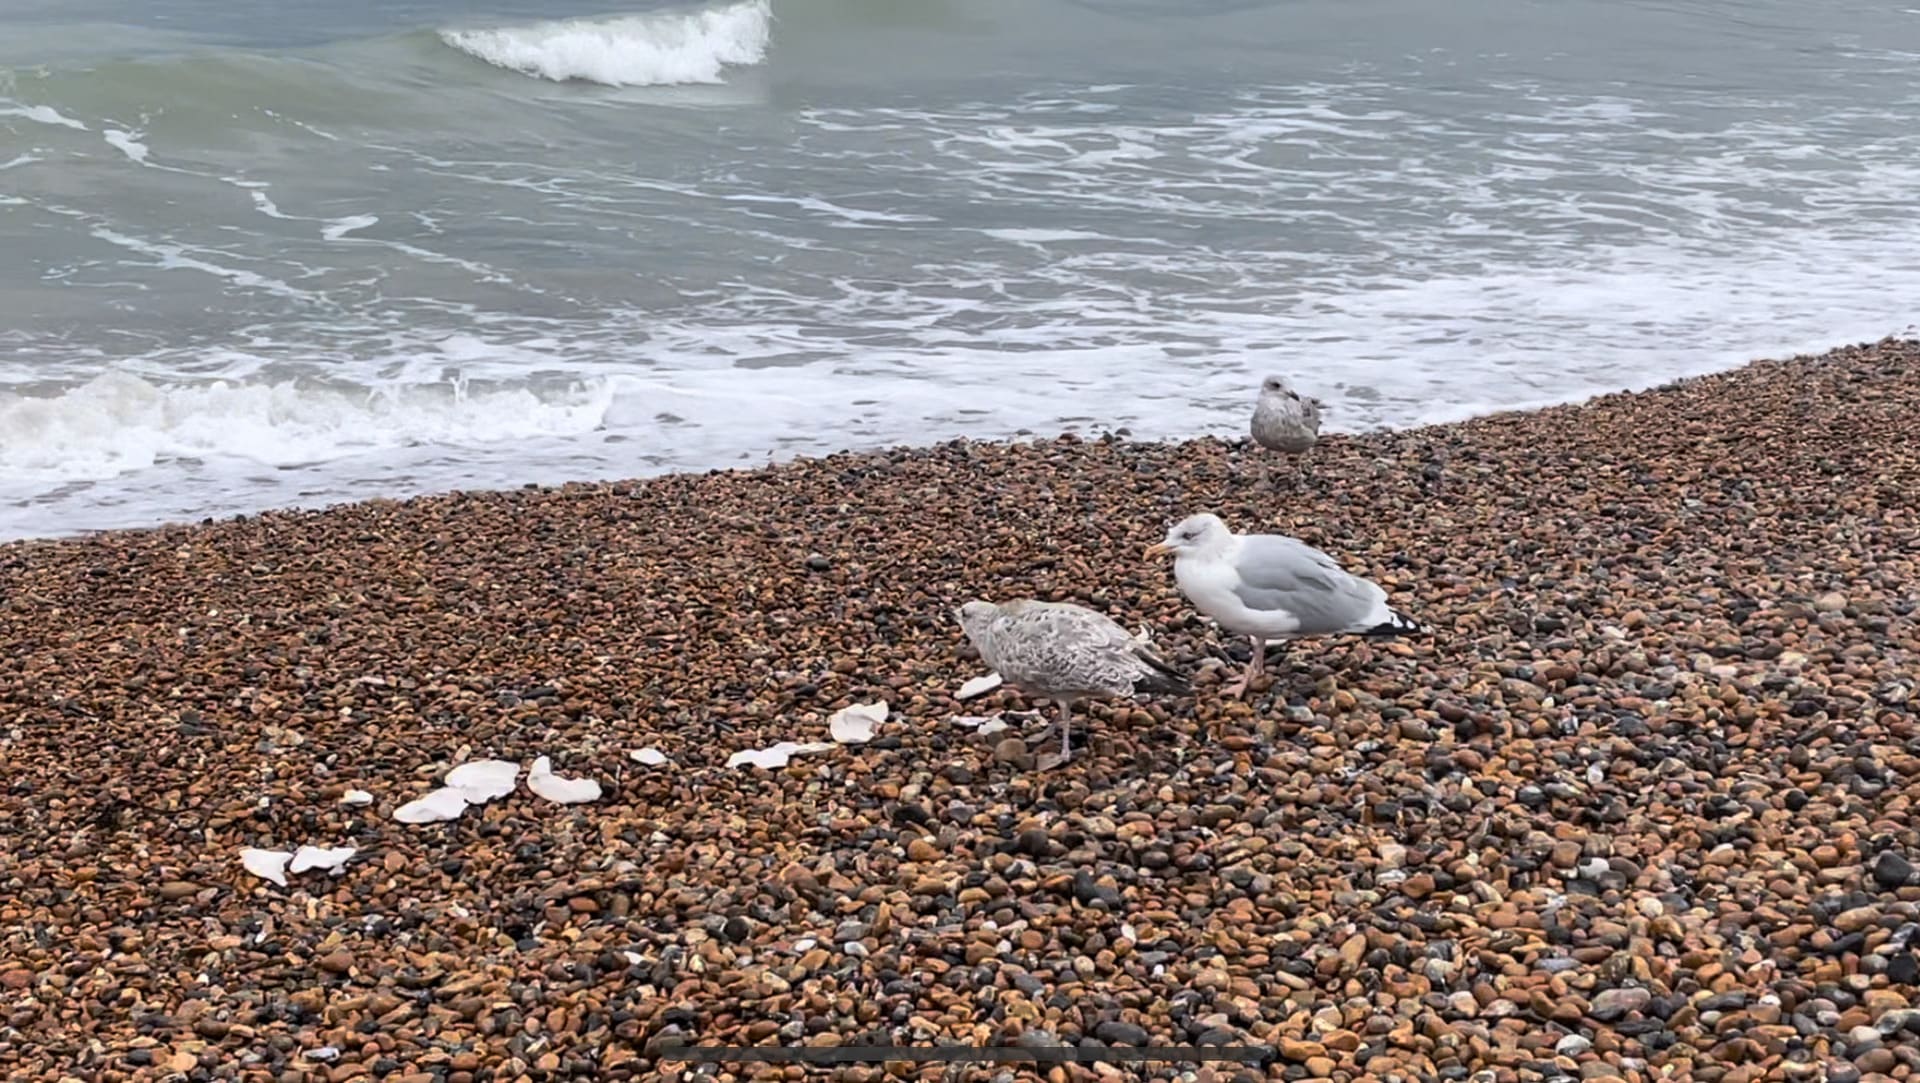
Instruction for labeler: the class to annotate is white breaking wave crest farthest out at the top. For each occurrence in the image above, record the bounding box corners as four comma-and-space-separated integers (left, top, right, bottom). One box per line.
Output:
440, 0, 774, 86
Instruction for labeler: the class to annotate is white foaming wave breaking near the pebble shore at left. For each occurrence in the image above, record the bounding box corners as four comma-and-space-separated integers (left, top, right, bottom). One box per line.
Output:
0, 371, 612, 482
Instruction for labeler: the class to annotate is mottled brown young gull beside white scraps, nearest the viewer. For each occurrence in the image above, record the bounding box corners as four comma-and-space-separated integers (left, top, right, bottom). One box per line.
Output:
954, 599, 1190, 770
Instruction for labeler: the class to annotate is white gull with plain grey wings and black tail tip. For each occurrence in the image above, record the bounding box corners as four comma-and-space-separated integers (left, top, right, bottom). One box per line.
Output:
1146, 513, 1430, 695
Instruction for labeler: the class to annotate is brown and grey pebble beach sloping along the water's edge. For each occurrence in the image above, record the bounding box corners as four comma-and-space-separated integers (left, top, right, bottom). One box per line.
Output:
0, 340, 1920, 1083
